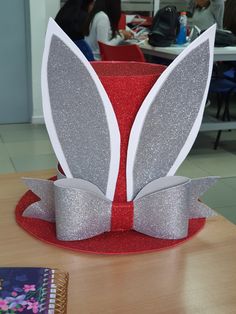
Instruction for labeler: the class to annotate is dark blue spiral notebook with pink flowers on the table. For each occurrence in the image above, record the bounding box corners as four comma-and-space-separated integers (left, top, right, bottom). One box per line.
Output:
0, 267, 68, 314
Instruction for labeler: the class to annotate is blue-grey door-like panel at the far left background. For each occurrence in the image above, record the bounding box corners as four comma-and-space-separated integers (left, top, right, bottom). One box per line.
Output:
0, 0, 32, 124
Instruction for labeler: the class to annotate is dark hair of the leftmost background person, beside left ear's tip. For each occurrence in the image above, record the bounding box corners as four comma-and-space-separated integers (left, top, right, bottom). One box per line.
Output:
55, 0, 94, 40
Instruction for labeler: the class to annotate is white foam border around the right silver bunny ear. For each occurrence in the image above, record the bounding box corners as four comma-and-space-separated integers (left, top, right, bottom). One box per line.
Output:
126, 24, 216, 201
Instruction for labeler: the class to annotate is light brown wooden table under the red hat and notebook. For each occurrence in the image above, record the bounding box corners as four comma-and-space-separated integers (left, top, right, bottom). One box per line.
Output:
0, 170, 236, 314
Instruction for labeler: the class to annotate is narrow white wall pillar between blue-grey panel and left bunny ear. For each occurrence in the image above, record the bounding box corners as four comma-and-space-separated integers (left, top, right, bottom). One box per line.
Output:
29, 0, 60, 123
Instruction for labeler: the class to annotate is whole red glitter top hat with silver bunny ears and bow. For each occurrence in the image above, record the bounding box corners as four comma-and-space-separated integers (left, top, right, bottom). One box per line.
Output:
16, 19, 217, 254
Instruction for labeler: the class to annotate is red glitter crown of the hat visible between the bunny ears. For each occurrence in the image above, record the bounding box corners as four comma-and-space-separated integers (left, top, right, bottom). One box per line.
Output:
92, 61, 166, 203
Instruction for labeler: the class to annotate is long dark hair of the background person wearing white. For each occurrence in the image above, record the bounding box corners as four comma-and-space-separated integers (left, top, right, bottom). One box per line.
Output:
85, 0, 121, 37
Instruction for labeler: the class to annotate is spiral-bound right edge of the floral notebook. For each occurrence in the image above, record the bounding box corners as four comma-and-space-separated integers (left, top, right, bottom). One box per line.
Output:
40, 268, 69, 314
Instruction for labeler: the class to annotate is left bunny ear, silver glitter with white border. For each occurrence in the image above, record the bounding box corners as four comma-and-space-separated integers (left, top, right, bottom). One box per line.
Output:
42, 19, 120, 200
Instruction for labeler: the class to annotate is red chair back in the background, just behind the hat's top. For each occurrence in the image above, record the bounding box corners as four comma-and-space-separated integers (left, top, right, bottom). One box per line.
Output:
98, 41, 145, 62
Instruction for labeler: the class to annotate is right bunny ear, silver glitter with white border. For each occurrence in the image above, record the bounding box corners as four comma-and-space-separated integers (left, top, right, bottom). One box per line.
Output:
126, 25, 216, 200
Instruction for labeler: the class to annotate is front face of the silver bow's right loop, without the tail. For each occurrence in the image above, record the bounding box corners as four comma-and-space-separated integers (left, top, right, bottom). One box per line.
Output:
134, 179, 189, 239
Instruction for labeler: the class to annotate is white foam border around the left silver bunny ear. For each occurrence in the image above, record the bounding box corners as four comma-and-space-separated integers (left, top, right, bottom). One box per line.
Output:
41, 18, 120, 200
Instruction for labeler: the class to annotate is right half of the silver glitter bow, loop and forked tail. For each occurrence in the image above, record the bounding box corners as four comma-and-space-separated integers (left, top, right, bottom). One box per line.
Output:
133, 177, 218, 239
